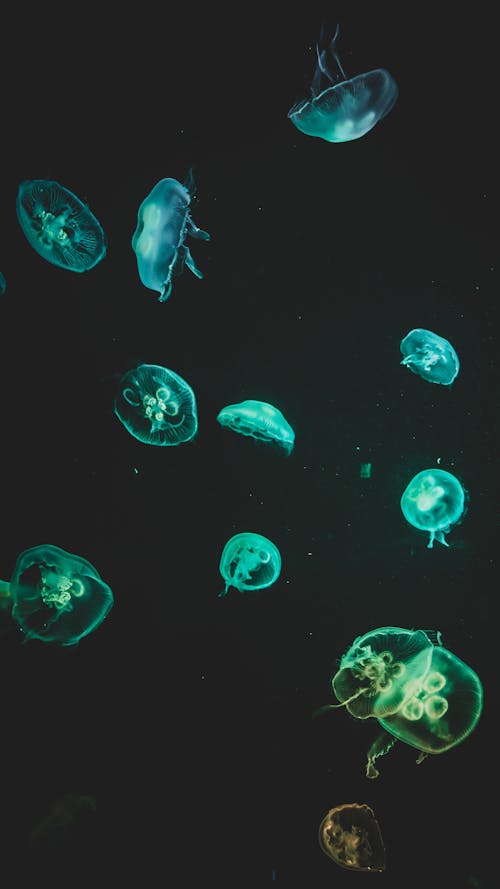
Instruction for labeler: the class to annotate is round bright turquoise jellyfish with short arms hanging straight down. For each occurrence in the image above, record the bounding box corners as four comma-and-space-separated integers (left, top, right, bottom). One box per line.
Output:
401, 469, 466, 549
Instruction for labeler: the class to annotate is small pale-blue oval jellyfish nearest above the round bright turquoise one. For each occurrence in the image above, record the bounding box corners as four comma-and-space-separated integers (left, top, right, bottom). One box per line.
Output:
400, 327, 460, 386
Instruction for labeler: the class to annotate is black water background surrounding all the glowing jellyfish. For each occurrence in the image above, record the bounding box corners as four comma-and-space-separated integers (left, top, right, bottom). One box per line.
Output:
0, 3, 499, 889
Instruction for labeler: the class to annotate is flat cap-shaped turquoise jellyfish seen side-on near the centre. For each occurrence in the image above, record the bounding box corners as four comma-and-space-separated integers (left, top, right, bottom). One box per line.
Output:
217, 399, 295, 456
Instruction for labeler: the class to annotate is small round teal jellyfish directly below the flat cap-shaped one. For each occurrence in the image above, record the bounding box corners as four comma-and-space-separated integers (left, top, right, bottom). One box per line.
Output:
219, 531, 281, 597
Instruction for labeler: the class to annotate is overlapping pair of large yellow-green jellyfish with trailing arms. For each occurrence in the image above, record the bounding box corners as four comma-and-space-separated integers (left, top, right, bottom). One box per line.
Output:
318, 627, 483, 778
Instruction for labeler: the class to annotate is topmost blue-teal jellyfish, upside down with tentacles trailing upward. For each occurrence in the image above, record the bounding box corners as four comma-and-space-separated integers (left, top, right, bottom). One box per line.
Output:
288, 25, 398, 142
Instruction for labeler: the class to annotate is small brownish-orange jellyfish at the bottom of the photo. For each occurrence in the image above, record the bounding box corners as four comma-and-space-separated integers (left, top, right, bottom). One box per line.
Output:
318, 803, 386, 873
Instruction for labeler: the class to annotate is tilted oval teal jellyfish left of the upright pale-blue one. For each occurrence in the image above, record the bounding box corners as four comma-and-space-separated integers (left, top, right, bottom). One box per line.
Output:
16, 179, 106, 272
